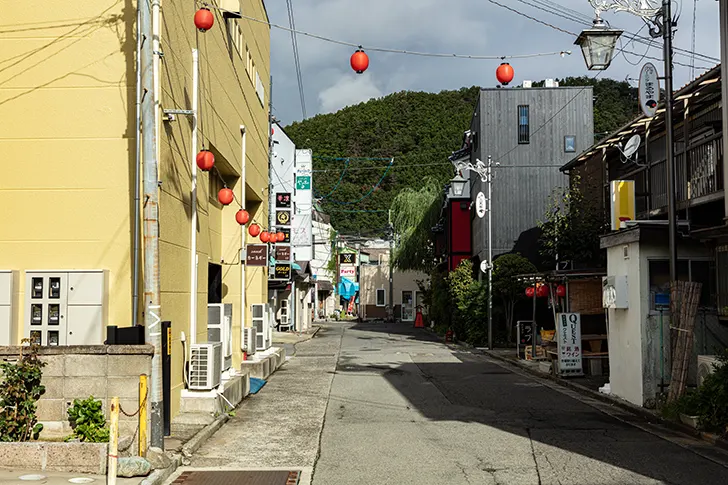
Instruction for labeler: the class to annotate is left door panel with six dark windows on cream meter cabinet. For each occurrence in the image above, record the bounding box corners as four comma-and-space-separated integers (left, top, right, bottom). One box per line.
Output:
25, 273, 68, 345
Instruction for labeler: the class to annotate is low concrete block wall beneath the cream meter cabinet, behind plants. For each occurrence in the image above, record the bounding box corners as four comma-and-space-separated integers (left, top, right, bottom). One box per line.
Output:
0, 345, 154, 454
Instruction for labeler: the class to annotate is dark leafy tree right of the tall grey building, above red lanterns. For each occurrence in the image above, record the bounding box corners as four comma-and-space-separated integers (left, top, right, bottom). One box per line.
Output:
538, 175, 607, 265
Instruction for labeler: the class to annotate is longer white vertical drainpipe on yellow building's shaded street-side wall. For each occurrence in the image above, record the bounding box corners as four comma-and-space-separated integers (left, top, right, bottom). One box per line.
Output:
190, 49, 200, 345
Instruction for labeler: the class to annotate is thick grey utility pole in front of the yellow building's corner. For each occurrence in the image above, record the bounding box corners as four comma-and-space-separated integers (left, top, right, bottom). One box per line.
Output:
139, 2, 164, 449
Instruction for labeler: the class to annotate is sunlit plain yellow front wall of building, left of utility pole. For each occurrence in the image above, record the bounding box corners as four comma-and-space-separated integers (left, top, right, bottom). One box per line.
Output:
0, 0, 135, 336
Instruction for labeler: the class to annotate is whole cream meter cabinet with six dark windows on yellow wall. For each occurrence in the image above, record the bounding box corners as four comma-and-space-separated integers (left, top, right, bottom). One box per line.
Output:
24, 270, 109, 346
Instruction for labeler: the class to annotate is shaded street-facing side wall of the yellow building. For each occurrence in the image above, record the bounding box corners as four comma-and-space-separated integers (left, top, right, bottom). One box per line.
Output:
160, 0, 270, 416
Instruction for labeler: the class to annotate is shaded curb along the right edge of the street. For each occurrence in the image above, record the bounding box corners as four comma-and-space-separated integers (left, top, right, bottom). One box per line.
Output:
479, 350, 728, 450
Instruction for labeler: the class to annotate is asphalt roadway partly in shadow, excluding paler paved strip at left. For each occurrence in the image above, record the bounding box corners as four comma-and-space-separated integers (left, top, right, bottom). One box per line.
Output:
313, 323, 728, 485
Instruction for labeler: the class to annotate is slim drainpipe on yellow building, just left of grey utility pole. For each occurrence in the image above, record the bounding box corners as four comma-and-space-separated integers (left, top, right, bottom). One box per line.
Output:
131, 5, 142, 326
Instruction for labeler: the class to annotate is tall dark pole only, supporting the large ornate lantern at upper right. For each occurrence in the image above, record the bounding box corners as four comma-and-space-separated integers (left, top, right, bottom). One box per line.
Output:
662, 0, 678, 285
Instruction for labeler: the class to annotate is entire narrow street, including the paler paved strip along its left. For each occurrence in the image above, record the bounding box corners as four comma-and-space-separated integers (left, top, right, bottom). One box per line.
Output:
175, 322, 728, 485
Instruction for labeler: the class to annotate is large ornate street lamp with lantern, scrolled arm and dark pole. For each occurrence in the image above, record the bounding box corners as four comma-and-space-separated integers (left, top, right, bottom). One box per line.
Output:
576, 0, 677, 284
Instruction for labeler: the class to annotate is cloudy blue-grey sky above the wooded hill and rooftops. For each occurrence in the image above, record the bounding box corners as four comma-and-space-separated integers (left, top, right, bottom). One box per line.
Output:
265, 0, 720, 125
